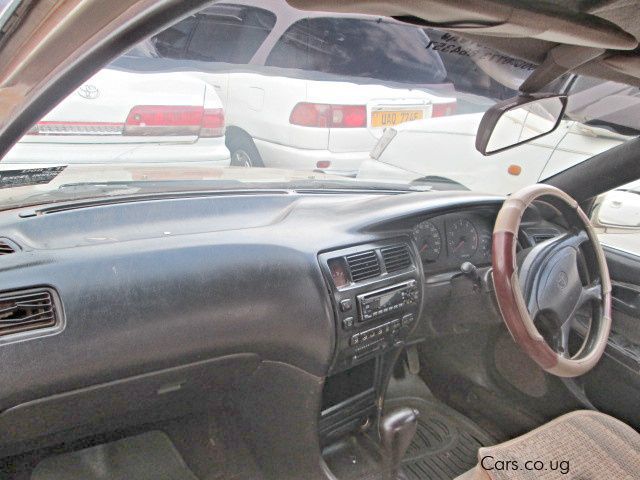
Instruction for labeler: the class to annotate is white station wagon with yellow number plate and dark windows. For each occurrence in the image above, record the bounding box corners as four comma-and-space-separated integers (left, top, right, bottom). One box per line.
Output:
114, 0, 456, 174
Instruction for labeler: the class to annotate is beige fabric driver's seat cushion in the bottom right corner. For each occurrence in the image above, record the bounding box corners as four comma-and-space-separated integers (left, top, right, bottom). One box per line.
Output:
457, 410, 640, 480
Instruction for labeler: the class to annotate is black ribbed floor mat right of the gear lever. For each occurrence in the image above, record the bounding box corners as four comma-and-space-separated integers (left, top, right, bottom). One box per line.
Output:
385, 398, 495, 480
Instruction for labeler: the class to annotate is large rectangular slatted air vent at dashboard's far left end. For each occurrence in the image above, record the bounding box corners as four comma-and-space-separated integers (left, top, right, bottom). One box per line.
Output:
0, 290, 56, 336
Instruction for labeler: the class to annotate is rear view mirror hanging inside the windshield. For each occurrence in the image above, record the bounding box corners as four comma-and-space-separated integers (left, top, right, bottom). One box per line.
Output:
476, 94, 567, 155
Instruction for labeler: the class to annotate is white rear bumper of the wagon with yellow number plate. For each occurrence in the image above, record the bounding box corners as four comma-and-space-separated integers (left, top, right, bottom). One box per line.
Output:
254, 139, 369, 176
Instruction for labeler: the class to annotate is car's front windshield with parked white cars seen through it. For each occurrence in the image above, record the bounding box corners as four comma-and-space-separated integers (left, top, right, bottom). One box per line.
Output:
0, 0, 640, 208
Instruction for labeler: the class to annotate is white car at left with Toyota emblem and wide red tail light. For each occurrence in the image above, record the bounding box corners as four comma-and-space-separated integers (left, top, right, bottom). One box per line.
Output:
0, 69, 230, 170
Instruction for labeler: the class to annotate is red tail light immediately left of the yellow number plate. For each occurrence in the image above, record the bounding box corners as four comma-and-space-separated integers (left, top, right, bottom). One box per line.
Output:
289, 102, 367, 128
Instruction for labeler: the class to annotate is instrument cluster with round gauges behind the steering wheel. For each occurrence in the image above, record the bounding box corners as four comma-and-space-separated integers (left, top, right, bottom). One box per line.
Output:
412, 213, 493, 270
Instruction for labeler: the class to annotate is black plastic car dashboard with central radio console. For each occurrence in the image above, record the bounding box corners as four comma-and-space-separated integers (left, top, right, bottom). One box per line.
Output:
0, 190, 564, 468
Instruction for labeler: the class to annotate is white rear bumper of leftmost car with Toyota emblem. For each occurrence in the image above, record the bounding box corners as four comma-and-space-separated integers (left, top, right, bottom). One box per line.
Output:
0, 137, 231, 165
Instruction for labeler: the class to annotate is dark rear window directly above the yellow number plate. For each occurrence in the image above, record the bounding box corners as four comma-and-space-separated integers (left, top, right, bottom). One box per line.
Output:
266, 18, 447, 84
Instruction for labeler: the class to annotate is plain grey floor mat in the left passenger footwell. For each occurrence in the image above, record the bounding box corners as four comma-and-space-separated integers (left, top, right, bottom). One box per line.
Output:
31, 431, 197, 480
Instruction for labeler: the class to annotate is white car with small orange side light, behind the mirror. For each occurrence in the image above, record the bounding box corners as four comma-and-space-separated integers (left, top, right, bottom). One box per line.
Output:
357, 113, 628, 195
